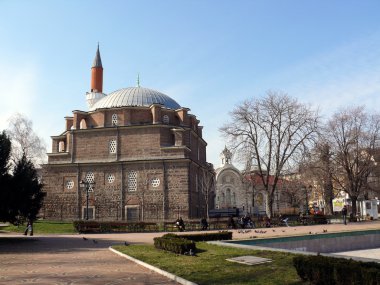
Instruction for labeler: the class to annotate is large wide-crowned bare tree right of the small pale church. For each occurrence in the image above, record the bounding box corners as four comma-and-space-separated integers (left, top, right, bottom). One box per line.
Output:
220, 91, 319, 216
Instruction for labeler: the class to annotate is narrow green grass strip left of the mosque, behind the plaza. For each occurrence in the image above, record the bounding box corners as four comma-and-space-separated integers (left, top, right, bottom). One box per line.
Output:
2, 220, 76, 234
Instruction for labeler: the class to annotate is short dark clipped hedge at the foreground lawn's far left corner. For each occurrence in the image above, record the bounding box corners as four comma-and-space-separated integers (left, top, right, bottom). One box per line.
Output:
153, 234, 196, 254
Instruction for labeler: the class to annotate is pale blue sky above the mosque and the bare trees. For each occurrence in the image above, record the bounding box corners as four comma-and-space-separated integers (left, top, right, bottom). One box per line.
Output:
0, 0, 380, 167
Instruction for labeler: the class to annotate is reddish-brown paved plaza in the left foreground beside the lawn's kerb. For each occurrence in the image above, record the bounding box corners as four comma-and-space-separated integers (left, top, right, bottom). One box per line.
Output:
0, 235, 177, 285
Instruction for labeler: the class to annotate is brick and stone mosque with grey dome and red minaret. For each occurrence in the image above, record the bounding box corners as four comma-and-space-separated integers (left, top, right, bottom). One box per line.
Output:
42, 46, 214, 222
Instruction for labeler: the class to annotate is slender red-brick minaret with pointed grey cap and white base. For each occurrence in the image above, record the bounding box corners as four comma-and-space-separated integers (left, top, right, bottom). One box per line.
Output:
86, 43, 106, 108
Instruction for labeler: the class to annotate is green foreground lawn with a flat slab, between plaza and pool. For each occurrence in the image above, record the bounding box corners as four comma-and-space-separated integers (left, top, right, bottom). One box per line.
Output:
114, 242, 304, 285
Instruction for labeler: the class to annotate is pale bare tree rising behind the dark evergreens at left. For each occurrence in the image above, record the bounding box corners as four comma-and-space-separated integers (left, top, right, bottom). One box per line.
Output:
7, 113, 46, 165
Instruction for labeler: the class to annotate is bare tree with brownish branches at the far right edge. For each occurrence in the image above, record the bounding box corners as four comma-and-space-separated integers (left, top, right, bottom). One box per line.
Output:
327, 107, 380, 213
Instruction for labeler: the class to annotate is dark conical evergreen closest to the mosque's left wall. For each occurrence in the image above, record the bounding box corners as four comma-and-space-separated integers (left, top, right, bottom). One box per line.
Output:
9, 155, 46, 223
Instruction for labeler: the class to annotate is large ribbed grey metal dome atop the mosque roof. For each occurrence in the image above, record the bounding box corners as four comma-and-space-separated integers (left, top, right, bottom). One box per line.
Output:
90, 87, 181, 111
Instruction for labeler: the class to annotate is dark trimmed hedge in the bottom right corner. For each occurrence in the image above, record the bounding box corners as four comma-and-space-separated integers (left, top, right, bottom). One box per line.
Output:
293, 255, 380, 285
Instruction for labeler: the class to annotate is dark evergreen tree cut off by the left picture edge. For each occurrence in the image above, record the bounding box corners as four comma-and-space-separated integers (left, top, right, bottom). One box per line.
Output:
0, 131, 11, 221
